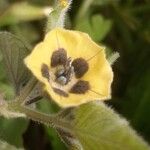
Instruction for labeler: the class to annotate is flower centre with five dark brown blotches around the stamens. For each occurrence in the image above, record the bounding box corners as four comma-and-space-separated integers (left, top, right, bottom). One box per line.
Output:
41, 48, 90, 97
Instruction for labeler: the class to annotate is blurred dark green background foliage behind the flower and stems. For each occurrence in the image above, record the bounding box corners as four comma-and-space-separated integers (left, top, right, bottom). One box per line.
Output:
0, 0, 150, 150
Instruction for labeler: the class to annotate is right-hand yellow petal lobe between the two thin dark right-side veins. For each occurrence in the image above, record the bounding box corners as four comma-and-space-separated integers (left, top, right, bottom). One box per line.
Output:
82, 51, 113, 99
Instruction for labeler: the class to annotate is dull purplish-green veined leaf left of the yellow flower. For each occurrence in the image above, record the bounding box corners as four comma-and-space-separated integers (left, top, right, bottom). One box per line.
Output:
0, 32, 29, 93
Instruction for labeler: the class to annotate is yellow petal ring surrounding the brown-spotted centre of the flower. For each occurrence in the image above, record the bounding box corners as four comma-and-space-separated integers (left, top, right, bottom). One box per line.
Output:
25, 28, 113, 107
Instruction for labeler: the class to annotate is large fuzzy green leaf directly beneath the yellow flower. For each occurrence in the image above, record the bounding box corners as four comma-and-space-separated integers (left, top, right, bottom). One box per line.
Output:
58, 102, 150, 150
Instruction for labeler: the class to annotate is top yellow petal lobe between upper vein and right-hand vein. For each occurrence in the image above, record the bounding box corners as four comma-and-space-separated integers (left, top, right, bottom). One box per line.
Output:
45, 28, 104, 60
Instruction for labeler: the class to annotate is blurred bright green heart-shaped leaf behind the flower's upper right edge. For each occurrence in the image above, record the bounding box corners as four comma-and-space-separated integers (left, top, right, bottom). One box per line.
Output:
76, 15, 112, 41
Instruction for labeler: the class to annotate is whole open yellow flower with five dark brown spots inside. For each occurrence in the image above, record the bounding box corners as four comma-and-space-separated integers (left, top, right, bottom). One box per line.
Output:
25, 28, 113, 107
